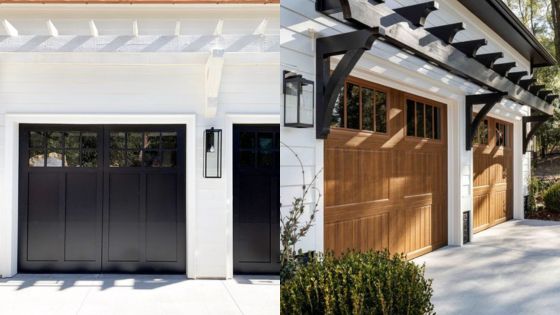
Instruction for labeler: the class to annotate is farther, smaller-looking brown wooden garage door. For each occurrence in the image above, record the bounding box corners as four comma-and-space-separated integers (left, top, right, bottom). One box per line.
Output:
473, 117, 513, 233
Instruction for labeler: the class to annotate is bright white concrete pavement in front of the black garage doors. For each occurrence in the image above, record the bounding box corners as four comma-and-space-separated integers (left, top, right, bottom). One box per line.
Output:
0, 275, 280, 315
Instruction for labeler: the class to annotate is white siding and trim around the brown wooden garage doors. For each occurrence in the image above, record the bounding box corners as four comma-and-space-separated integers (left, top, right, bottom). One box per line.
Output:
280, 0, 530, 254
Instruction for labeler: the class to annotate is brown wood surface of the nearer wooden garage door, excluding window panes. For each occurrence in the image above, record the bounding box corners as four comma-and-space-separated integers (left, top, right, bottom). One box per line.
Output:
324, 82, 447, 258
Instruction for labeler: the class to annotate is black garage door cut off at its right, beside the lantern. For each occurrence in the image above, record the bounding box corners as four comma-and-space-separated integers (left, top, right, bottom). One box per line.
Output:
233, 125, 280, 274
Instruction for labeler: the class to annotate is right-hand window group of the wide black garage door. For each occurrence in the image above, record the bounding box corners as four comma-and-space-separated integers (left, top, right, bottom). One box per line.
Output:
110, 131, 177, 168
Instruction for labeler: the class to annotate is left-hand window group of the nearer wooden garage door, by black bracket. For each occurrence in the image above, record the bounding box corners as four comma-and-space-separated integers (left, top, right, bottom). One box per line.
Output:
331, 82, 387, 133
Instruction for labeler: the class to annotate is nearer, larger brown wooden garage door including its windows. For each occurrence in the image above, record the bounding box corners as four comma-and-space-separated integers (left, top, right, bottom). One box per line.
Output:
324, 79, 447, 258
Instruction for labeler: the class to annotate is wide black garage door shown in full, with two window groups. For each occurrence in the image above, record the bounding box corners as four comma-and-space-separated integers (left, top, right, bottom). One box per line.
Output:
19, 125, 186, 274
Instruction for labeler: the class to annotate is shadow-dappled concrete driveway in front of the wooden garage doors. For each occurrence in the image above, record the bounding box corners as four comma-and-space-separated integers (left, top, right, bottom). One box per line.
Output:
414, 220, 560, 315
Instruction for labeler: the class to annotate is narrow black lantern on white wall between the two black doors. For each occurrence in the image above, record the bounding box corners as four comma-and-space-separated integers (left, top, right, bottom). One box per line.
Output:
204, 127, 222, 178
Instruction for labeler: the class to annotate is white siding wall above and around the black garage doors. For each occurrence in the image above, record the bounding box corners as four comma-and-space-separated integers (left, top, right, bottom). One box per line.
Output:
0, 5, 280, 278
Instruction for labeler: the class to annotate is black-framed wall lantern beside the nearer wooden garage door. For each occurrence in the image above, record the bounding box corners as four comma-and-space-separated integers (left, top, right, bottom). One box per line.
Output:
284, 71, 315, 128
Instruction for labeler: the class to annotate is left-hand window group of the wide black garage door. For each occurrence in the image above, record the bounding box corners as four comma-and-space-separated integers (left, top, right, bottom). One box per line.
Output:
28, 130, 98, 168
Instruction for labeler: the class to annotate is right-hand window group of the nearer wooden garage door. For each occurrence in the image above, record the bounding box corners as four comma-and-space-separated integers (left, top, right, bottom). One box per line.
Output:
406, 99, 441, 140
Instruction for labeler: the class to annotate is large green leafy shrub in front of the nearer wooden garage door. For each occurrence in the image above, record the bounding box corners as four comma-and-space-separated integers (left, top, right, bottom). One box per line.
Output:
281, 251, 434, 315
